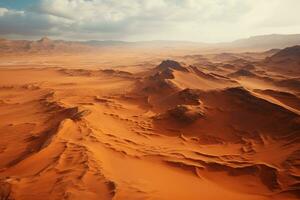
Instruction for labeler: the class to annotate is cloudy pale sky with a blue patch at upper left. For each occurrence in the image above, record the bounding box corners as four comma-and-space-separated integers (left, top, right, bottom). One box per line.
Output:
0, 0, 300, 42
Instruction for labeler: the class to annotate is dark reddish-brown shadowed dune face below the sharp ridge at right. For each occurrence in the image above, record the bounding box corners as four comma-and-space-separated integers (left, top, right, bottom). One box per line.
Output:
155, 88, 300, 141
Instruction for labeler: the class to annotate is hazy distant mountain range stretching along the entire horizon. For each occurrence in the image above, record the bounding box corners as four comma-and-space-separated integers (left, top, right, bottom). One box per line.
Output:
0, 34, 300, 53
